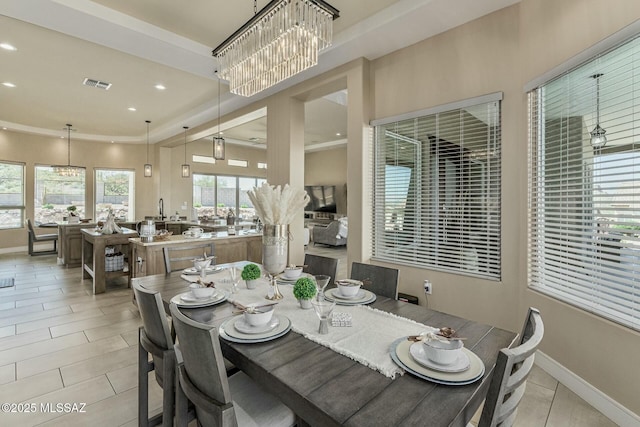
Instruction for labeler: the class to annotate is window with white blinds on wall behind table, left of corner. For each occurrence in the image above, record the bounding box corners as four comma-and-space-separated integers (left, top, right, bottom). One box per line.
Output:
372, 94, 502, 279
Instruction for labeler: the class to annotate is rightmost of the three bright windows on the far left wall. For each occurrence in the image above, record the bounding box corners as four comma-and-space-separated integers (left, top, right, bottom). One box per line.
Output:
95, 169, 136, 221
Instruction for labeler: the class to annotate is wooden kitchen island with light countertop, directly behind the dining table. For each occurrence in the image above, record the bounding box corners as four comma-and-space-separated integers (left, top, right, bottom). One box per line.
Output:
129, 231, 262, 277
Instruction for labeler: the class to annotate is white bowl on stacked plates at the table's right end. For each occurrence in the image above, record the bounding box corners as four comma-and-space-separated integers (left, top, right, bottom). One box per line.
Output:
390, 328, 485, 385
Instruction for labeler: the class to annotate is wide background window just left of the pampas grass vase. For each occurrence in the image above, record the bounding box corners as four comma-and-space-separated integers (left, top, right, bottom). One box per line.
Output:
193, 174, 266, 221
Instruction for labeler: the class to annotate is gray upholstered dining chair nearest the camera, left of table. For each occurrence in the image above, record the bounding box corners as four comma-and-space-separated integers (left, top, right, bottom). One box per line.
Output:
170, 304, 296, 427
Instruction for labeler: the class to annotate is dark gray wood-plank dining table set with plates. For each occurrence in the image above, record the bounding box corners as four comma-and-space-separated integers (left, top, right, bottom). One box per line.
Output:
132, 261, 517, 427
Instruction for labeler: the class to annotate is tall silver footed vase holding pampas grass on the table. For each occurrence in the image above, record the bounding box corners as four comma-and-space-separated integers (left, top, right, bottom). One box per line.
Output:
262, 224, 289, 300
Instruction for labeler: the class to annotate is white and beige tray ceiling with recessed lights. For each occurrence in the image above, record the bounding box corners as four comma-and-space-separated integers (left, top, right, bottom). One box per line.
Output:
0, 0, 518, 145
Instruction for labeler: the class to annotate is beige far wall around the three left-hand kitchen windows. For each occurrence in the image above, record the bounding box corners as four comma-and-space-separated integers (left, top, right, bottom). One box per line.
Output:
0, 131, 157, 252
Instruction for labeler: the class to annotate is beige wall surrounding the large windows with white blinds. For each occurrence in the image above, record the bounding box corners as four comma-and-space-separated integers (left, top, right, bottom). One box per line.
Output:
370, 0, 640, 414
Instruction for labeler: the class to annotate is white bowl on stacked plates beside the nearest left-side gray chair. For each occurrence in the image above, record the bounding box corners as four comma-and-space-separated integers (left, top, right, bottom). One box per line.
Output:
218, 301, 291, 343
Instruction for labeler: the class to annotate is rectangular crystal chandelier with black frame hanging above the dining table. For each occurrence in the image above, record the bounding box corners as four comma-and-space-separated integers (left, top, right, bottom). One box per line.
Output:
213, 0, 340, 96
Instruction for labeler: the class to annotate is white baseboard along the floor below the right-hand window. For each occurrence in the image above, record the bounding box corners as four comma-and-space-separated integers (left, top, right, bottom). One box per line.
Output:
536, 350, 640, 427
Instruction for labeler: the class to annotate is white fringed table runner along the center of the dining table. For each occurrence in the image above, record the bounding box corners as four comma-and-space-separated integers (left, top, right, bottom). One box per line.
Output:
182, 271, 435, 378
